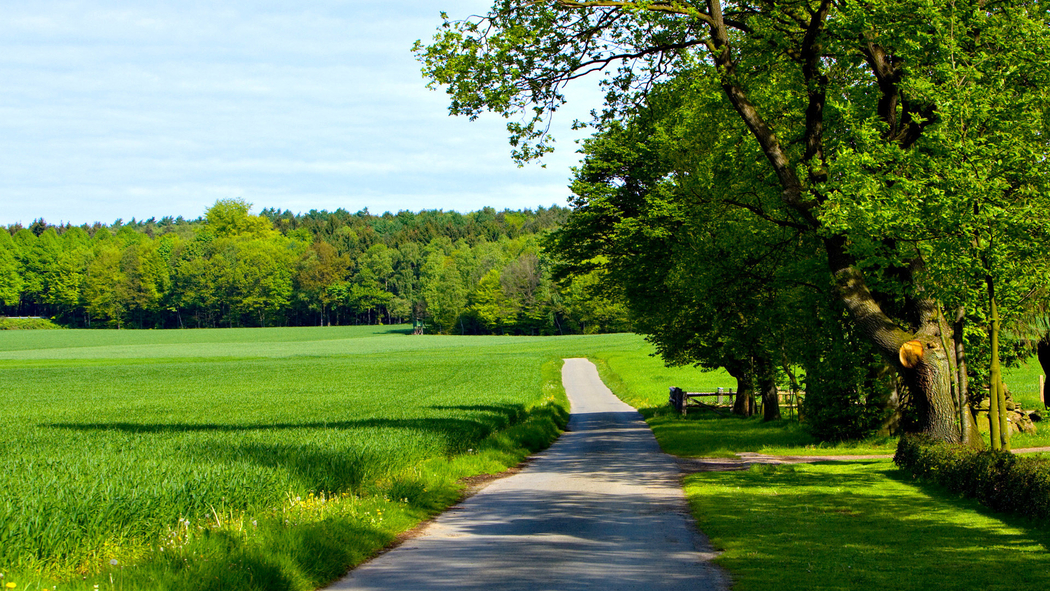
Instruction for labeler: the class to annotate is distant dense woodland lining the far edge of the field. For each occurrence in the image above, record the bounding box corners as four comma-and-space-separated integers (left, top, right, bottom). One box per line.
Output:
0, 199, 629, 334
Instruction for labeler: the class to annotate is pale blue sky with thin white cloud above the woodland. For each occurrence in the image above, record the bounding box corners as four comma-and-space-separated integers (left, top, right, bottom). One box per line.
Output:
0, 0, 600, 225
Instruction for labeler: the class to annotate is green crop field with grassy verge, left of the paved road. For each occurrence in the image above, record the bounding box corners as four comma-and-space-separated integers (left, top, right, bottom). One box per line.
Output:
0, 326, 647, 590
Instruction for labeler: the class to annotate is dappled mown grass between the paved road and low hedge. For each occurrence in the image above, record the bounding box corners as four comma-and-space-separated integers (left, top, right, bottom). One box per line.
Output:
685, 461, 1050, 591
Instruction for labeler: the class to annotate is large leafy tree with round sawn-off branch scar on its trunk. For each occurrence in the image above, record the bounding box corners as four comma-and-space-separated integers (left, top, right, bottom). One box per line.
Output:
417, 0, 1050, 443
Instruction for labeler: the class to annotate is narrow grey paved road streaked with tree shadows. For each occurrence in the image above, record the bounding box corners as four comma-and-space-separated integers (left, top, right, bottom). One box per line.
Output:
331, 359, 727, 591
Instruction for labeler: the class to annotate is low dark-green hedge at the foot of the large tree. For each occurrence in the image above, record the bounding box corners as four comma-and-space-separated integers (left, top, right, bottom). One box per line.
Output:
894, 436, 1050, 520
